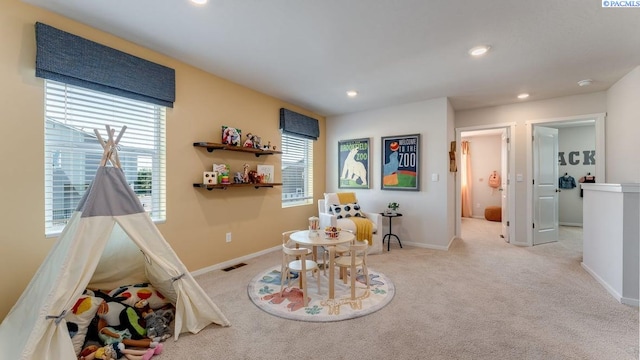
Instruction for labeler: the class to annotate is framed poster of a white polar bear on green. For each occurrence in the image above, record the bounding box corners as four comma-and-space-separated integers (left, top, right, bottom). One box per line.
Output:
338, 138, 369, 189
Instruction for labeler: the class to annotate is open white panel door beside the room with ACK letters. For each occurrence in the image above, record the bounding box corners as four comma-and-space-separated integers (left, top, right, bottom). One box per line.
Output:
533, 126, 560, 245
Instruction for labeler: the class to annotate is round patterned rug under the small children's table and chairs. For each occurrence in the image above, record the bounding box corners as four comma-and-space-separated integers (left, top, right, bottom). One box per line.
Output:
247, 266, 395, 322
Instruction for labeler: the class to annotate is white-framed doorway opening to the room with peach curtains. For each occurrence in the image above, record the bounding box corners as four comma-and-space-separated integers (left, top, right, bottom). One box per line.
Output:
455, 123, 515, 242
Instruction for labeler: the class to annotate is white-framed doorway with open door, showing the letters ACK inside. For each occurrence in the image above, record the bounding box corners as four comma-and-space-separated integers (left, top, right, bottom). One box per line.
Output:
526, 114, 606, 246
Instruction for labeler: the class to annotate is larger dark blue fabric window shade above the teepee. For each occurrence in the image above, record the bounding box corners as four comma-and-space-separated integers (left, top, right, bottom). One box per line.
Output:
36, 22, 176, 107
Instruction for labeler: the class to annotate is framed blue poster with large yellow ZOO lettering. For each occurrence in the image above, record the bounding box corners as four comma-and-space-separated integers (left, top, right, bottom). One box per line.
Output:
380, 134, 420, 191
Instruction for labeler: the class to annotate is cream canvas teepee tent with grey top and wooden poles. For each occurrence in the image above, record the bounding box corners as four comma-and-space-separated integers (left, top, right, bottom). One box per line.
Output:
0, 126, 230, 360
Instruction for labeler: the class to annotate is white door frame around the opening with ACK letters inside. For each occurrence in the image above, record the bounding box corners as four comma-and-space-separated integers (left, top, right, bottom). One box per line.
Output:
525, 113, 607, 246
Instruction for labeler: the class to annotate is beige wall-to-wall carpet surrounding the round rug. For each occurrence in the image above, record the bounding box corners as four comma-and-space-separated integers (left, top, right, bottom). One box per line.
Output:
161, 219, 639, 360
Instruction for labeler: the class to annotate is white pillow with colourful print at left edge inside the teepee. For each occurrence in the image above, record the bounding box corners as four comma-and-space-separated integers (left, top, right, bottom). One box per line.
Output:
65, 295, 104, 355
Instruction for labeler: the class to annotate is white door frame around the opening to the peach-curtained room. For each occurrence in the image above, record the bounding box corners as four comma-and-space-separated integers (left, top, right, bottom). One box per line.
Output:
455, 122, 516, 243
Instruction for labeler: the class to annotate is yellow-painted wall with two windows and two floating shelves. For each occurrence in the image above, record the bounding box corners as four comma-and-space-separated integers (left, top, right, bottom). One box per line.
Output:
0, 0, 325, 318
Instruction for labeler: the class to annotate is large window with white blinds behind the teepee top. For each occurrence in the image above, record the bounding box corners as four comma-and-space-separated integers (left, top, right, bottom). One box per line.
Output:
44, 80, 166, 236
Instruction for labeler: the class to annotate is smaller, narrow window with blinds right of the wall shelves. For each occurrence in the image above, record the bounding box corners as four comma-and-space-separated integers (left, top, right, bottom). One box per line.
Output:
282, 134, 313, 207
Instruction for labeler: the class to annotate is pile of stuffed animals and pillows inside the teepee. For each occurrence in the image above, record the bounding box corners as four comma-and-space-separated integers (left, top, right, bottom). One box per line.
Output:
67, 283, 175, 360
